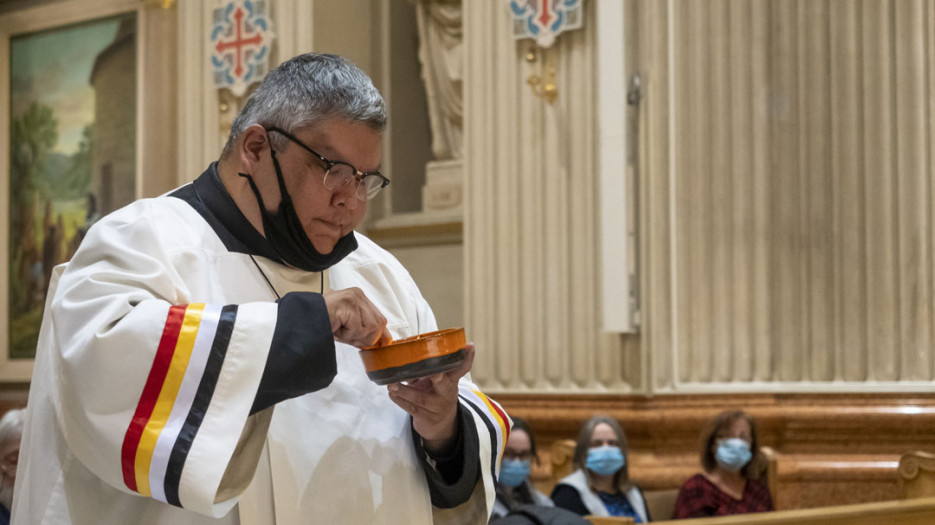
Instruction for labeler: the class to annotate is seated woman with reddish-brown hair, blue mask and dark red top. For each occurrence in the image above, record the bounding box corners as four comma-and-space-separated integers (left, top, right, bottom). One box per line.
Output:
673, 410, 773, 519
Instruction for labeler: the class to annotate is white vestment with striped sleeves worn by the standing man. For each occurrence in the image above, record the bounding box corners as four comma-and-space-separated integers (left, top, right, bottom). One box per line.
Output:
13, 174, 510, 525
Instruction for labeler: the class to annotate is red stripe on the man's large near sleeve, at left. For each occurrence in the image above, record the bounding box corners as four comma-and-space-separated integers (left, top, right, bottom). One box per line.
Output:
120, 306, 186, 492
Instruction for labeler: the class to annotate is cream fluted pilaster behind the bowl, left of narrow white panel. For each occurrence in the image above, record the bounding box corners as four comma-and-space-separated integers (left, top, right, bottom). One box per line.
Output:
463, 2, 643, 392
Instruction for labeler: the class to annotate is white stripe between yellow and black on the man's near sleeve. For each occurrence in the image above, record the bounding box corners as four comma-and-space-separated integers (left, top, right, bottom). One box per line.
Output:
149, 304, 221, 502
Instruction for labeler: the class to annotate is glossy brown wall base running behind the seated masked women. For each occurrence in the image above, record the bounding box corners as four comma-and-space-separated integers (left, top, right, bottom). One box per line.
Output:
498, 392, 935, 510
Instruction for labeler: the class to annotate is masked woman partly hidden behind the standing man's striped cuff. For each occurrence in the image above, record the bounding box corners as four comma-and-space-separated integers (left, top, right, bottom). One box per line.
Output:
491, 417, 554, 519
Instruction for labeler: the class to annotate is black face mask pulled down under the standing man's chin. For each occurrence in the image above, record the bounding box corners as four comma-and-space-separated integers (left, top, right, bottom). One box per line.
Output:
238, 148, 357, 272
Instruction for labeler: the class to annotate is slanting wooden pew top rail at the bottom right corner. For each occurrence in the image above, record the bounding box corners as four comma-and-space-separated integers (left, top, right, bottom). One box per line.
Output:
653, 498, 935, 525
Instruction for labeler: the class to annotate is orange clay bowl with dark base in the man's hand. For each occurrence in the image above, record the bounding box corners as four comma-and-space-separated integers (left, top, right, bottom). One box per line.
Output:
360, 328, 467, 385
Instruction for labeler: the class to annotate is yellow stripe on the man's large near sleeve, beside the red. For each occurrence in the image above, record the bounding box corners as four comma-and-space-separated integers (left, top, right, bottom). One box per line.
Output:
135, 303, 205, 496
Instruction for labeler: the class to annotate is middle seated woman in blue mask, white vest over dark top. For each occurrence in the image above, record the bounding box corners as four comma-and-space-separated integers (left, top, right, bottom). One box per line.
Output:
552, 417, 649, 523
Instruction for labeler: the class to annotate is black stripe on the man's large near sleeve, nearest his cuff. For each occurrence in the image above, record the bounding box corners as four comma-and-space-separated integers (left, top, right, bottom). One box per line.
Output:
163, 304, 237, 507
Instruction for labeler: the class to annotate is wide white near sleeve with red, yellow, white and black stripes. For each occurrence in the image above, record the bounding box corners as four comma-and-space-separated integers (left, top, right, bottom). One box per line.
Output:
51, 202, 335, 516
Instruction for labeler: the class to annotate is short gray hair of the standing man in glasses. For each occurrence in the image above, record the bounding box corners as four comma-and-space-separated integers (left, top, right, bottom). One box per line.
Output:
221, 53, 386, 158
